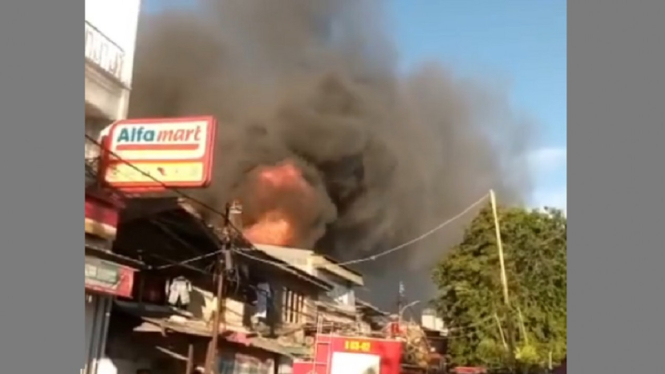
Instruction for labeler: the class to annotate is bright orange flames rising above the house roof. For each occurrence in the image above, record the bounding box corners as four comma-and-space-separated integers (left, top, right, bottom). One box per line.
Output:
244, 161, 311, 246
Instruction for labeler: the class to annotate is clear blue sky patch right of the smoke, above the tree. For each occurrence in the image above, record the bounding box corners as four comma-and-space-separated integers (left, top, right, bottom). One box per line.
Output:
391, 0, 567, 209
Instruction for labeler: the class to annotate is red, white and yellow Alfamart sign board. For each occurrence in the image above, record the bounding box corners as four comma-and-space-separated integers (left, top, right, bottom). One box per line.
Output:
102, 117, 216, 190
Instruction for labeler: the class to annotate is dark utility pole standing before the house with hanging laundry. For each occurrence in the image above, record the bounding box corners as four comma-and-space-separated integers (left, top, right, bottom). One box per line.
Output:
204, 206, 233, 374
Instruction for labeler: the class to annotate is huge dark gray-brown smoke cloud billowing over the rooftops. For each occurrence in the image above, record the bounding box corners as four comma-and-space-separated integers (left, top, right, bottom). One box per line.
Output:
130, 0, 532, 307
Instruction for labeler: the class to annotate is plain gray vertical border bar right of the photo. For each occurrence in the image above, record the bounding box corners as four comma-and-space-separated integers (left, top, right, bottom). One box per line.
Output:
568, 0, 665, 374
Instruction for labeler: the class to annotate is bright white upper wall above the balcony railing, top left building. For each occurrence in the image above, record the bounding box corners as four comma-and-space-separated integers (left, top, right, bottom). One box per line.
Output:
85, 0, 141, 86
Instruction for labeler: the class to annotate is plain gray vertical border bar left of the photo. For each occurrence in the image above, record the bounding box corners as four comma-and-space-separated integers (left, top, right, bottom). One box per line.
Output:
0, 1, 84, 373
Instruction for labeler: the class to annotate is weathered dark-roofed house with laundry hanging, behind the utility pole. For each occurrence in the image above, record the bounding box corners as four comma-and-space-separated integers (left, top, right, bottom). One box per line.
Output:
100, 197, 333, 374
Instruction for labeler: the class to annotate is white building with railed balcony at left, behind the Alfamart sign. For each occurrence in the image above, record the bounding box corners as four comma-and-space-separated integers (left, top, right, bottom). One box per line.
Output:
81, 0, 140, 374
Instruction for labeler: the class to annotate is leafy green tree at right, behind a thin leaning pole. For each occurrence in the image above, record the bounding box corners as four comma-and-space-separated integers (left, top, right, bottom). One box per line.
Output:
433, 207, 567, 372
